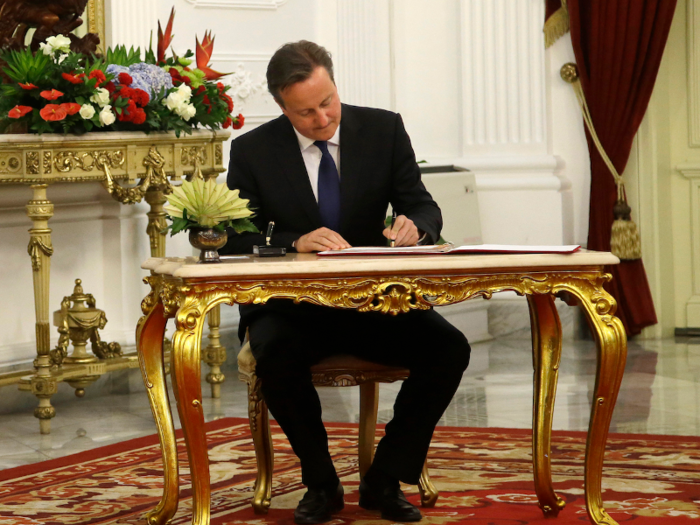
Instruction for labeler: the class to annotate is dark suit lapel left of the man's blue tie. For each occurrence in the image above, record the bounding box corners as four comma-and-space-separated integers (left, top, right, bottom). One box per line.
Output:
276, 116, 321, 228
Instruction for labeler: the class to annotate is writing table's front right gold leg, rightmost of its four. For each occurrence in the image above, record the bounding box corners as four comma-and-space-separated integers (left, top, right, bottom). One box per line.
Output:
572, 285, 627, 525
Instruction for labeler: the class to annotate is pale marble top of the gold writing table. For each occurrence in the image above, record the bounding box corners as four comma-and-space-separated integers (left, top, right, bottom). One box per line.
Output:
141, 250, 620, 279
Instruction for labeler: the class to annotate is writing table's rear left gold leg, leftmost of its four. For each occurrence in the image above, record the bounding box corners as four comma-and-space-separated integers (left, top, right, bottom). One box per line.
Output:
136, 296, 178, 525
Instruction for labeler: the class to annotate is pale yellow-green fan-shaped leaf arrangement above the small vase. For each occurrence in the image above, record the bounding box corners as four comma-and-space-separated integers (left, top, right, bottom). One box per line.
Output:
163, 178, 258, 235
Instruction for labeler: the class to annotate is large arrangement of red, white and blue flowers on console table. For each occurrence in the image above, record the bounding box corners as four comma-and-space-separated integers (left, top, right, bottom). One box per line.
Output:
0, 9, 245, 136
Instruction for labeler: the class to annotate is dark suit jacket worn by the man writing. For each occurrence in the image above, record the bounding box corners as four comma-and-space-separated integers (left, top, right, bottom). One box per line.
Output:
220, 104, 442, 329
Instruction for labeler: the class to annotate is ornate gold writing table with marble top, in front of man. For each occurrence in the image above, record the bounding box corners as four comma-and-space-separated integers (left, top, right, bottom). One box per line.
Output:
136, 251, 627, 525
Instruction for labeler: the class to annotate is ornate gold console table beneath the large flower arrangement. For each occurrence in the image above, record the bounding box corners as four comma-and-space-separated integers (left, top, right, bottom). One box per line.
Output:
0, 130, 230, 434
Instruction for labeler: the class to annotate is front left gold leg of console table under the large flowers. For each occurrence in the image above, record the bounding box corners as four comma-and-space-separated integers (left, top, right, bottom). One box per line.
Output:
27, 184, 58, 434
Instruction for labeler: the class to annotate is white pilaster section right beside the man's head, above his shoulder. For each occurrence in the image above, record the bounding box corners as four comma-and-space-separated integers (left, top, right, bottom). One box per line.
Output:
333, 0, 391, 108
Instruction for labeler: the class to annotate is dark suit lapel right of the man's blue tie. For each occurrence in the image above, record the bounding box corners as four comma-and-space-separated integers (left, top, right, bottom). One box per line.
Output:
340, 104, 364, 229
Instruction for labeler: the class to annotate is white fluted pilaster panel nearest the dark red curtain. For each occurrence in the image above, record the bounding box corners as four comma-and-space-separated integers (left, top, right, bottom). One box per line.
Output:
461, 0, 547, 155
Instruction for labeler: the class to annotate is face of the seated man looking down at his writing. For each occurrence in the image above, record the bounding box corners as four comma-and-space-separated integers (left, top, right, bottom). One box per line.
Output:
280, 67, 340, 140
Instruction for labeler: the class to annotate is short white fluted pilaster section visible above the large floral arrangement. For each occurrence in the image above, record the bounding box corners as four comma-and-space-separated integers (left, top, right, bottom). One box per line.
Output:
105, 0, 159, 53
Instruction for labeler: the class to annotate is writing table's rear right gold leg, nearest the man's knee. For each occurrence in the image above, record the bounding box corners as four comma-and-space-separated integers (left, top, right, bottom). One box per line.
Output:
527, 295, 565, 516
